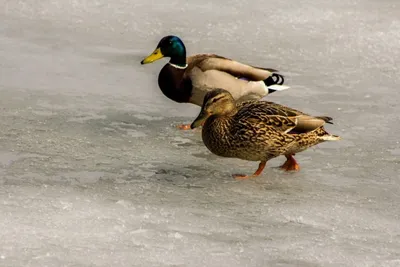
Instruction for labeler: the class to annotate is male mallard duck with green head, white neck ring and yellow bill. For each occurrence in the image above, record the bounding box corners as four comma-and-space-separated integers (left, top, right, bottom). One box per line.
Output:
141, 35, 289, 129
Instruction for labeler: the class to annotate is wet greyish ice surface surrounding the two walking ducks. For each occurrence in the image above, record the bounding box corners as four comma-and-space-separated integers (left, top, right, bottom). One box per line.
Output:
0, 0, 400, 267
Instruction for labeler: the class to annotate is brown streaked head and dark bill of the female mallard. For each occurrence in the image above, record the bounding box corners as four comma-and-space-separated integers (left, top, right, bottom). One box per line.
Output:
190, 89, 236, 129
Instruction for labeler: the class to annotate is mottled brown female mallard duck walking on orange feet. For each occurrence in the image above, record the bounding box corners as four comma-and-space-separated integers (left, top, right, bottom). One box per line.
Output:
191, 89, 340, 179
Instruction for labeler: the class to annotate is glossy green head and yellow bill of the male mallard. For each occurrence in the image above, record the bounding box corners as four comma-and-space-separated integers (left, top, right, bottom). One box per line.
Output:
141, 35, 186, 67
